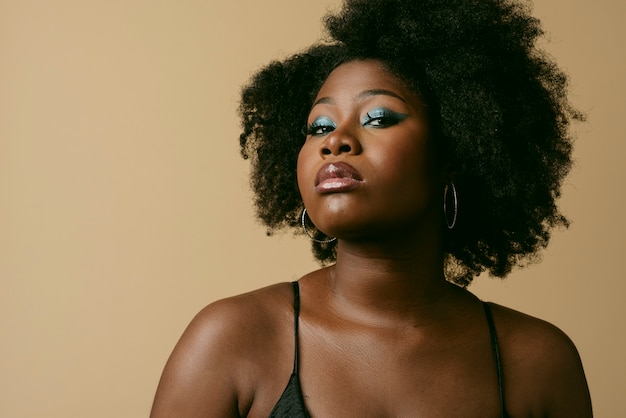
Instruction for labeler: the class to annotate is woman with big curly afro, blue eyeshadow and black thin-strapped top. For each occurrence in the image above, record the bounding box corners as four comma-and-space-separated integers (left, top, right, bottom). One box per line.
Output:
152, 0, 592, 418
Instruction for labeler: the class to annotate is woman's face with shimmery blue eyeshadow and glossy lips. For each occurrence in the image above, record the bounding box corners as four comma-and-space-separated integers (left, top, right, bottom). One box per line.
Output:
298, 60, 443, 239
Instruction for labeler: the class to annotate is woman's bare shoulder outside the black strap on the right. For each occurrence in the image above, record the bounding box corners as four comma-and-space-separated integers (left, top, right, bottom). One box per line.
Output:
490, 304, 592, 417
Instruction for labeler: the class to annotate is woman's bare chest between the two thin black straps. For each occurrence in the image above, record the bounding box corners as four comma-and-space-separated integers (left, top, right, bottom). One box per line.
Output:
299, 322, 499, 418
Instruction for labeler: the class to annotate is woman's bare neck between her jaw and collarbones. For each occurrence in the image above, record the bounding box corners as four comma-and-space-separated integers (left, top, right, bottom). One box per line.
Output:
329, 235, 457, 323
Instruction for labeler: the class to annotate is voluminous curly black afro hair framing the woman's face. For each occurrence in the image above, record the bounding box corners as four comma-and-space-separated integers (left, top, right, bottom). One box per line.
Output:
239, 0, 583, 285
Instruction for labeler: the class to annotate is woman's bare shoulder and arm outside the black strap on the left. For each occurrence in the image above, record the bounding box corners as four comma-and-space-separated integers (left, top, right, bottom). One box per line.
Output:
151, 283, 293, 418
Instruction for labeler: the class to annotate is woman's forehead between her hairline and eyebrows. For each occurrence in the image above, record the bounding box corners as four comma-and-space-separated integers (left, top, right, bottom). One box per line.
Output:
316, 60, 417, 101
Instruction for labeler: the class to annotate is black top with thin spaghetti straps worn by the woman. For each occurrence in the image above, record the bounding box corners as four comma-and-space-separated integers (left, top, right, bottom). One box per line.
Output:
270, 282, 509, 418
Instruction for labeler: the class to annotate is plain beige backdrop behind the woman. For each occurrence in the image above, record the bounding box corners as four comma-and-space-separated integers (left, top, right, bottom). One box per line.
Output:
0, 0, 626, 418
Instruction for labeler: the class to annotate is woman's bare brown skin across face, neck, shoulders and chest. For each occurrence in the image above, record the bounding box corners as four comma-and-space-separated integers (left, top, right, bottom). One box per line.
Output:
151, 61, 592, 418
